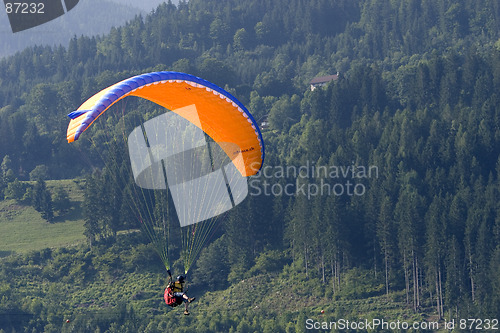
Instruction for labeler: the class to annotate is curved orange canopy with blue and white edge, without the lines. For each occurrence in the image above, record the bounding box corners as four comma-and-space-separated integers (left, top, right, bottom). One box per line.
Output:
67, 72, 265, 176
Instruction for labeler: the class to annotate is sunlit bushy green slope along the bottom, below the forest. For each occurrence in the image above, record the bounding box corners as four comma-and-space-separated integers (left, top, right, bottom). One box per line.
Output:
1, 265, 444, 332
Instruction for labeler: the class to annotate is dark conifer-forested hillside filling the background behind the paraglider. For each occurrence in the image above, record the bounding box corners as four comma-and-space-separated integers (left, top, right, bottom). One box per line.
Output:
0, 0, 500, 332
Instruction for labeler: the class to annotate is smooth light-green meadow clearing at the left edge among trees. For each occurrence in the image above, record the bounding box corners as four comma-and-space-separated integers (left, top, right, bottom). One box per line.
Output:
0, 180, 85, 256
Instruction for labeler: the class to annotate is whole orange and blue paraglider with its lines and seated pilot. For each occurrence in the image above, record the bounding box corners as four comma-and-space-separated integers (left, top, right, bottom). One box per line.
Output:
67, 72, 265, 312
